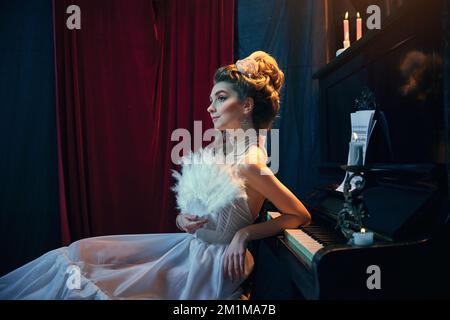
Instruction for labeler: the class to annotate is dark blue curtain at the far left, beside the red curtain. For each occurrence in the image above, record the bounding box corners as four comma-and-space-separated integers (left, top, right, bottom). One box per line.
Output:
0, 0, 60, 274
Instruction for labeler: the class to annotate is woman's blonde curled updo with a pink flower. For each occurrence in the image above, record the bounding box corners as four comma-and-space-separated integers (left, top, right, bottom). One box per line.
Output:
214, 51, 284, 130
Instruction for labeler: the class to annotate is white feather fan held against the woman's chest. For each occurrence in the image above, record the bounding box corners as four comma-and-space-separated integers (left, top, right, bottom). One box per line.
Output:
171, 148, 247, 217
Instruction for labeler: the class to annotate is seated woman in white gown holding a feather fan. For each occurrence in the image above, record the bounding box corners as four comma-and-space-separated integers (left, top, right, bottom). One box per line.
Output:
0, 51, 310, 299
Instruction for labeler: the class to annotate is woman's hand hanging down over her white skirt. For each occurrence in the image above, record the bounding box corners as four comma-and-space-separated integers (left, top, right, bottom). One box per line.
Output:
223, 231, 247, 282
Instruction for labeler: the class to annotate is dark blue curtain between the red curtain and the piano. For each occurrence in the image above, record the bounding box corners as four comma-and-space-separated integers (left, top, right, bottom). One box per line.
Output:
235, 0, 325, 198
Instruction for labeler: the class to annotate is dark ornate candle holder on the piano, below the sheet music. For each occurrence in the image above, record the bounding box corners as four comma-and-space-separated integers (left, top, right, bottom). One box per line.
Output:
336, 166, 369, 240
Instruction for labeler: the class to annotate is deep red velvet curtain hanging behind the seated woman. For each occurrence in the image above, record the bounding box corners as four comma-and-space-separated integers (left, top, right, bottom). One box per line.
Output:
54, 0, 235, 244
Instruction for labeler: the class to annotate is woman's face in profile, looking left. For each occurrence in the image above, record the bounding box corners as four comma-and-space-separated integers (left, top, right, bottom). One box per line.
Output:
207, 81, 244, 130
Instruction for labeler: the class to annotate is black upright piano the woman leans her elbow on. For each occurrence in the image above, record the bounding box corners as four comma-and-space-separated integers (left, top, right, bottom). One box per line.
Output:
247, 0, 450, 300
